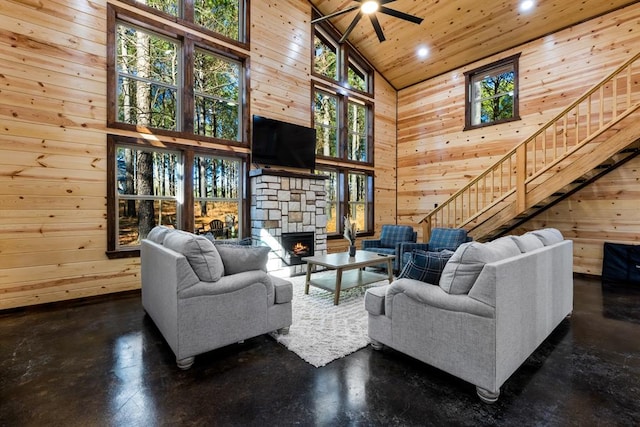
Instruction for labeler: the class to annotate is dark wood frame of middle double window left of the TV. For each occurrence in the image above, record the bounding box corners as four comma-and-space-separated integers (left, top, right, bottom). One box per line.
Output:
107, 2, 250, 147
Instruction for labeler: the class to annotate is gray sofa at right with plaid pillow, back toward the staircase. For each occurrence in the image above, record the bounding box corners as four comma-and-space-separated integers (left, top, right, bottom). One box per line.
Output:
365, 229, 573, 403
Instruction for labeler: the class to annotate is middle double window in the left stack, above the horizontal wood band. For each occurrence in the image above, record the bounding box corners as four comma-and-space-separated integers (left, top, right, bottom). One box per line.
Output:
108, 6, 247, 143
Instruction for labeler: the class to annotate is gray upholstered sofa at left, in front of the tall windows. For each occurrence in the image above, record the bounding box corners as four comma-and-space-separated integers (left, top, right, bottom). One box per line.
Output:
141, 227, 293, 369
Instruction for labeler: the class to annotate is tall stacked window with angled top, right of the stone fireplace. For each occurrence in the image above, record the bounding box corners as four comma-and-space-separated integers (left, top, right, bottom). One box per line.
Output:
312, 17, 374, 238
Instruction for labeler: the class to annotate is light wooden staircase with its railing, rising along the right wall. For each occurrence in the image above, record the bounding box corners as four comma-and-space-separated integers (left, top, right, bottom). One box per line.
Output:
421, 53, 640, 241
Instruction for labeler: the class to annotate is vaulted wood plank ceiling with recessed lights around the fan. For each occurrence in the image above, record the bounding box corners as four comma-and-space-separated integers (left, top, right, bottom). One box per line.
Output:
310, 0, 637, 89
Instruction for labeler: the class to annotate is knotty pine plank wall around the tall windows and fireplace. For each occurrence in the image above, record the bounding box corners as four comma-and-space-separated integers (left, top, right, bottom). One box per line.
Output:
0, 0, 396, 310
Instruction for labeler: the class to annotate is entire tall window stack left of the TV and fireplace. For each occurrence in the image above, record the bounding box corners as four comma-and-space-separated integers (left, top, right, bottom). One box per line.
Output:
107, 0, 249, 257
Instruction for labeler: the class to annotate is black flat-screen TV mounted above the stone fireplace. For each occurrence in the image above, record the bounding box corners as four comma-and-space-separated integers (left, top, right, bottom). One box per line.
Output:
251, 116, 316, 170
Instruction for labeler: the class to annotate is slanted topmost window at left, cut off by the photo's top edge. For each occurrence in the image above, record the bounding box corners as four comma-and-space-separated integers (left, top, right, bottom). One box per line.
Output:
135, 0, 247, 42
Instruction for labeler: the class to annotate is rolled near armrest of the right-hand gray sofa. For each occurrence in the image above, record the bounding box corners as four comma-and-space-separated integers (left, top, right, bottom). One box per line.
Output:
385, 278, 495, 318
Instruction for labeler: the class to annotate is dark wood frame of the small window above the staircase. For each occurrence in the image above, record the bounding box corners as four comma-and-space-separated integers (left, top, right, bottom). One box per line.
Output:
463, 53, 520, 131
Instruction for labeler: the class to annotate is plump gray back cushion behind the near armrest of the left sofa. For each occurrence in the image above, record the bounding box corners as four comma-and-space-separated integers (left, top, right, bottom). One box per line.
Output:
164, 230, 224, 282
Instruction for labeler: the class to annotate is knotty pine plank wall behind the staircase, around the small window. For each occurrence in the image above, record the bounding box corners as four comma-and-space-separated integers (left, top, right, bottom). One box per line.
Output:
398, 4, 640, 274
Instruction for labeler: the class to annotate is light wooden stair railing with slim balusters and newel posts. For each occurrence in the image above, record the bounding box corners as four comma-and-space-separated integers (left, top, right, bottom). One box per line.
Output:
420, 52, 640, 241
